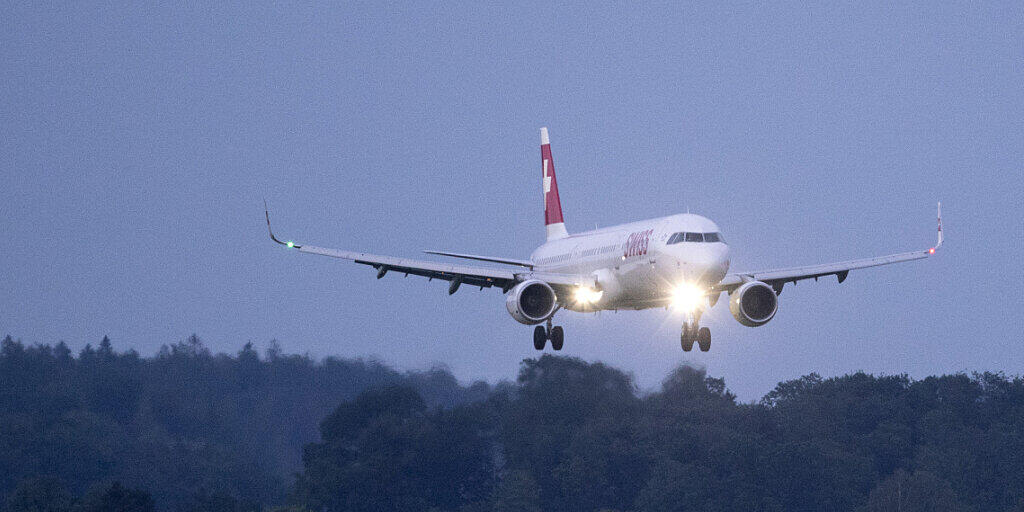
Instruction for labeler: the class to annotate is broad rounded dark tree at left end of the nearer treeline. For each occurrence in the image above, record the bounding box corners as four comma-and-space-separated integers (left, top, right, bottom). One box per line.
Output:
294, 385, 493, 512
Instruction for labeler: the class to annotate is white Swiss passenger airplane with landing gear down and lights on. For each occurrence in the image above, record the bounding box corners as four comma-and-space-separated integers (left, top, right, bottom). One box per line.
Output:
263, 128, 942, 352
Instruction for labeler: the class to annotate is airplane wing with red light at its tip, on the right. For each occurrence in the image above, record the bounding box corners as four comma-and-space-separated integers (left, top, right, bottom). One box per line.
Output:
713, 203, 942, 294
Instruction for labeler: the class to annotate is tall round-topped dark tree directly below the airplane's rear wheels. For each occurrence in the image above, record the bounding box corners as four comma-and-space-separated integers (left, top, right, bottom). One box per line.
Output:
501, 355, 645, 512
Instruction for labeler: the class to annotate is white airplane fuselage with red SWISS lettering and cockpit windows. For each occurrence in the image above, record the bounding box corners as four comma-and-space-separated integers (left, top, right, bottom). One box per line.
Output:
530, 214, 729, 311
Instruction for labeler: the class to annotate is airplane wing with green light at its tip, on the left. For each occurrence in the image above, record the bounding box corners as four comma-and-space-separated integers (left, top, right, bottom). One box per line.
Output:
265, 203, 597, 294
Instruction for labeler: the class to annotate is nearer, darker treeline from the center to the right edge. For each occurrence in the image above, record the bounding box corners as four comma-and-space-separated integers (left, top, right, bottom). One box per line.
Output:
291, 355, 1024, 512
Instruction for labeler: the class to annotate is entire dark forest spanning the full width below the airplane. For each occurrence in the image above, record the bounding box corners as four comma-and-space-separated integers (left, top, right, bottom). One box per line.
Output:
0, 336, 1024, 512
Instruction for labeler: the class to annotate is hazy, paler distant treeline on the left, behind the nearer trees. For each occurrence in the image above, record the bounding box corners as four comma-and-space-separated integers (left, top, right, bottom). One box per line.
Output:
0, 336, 490, 510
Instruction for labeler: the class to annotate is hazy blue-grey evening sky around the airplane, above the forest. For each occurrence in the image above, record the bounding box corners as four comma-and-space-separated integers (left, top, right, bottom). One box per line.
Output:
0, 2, 1024, 399
